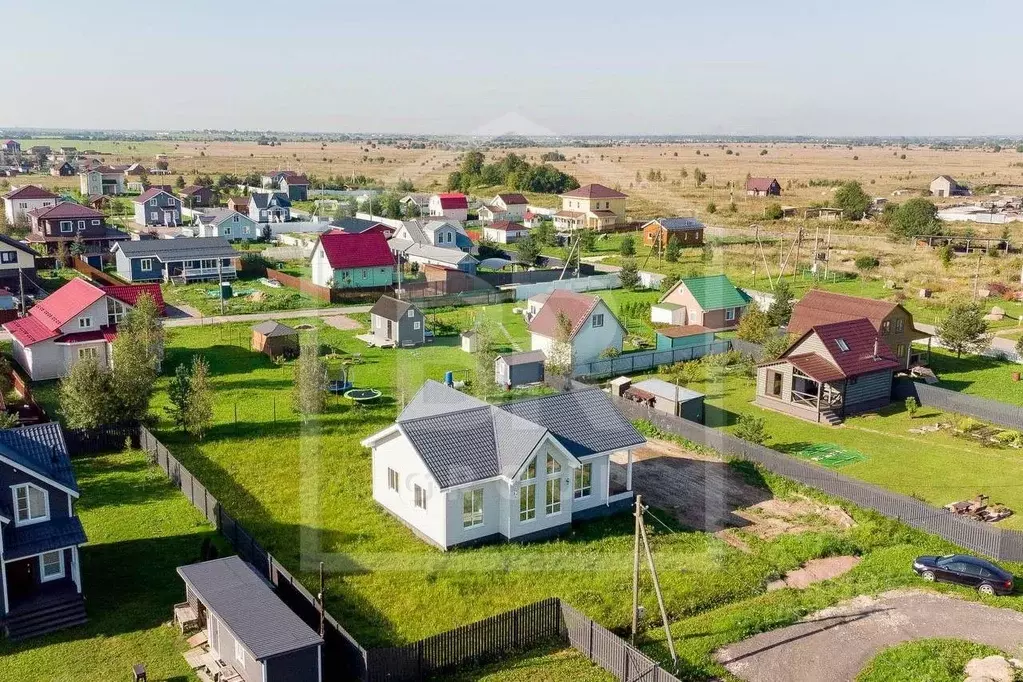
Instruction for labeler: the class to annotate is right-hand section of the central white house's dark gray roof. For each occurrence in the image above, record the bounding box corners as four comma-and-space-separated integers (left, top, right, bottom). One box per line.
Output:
501, 389, 647, 457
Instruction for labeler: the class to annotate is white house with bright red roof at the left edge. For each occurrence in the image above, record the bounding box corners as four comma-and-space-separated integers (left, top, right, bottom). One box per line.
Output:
3, 280, 164, 381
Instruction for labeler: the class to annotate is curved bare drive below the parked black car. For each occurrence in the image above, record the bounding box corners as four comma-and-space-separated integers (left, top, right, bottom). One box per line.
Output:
716, 591, 1023, 682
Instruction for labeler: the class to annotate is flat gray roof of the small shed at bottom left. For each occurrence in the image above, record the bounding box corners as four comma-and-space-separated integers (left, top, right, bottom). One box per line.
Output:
178, 556, 323, 661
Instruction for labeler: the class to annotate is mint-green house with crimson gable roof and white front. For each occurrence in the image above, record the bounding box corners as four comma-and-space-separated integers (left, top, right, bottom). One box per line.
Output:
310, 230, 395, 289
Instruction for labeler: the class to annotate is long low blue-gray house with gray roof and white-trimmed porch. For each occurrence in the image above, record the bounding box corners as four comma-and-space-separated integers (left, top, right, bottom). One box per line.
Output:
113, 236, 238, 283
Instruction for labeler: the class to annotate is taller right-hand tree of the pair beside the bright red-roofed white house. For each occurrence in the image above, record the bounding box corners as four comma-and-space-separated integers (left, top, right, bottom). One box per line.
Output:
110, 294, 164, 423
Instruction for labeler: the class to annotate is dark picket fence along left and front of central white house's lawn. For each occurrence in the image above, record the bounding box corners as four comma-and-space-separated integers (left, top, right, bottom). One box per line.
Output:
123, 426, 678, 682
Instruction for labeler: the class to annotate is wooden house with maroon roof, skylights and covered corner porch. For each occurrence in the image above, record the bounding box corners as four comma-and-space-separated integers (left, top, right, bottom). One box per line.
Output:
754, 317, 899, 425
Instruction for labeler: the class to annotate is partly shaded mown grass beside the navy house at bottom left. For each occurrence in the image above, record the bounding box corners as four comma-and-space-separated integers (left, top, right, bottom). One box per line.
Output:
0, 451, 226, 682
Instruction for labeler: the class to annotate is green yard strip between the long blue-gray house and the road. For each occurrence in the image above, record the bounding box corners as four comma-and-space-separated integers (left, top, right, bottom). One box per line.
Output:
164, 279, 326, 316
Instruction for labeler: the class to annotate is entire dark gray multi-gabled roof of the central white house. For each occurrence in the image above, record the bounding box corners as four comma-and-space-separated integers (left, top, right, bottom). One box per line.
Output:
397, 381, 644, 489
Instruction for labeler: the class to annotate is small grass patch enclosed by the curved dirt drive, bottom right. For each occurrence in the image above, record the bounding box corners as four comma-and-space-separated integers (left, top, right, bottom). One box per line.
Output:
856, 639, 1006, 682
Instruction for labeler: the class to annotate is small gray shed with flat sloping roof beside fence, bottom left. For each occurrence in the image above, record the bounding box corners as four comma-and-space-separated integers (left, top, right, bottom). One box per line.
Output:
178, 556, 323, 682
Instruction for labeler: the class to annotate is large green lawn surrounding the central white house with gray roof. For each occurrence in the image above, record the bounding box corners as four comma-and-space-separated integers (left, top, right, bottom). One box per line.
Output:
39, 316, 1016, 680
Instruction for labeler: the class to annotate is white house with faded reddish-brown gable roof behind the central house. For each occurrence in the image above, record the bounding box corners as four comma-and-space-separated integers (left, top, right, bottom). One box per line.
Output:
528, 289, 625, 366
